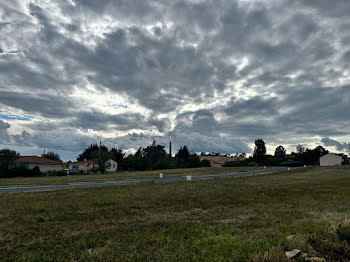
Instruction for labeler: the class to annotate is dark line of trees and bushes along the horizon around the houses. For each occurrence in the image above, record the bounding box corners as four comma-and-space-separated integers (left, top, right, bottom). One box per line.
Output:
0, 139, 344, 177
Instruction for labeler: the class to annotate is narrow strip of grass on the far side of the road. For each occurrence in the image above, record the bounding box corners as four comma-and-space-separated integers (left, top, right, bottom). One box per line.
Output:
0, 167, 261, 186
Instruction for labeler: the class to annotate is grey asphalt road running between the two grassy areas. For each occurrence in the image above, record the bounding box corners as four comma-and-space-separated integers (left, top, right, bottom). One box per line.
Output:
0, 167, 288, 193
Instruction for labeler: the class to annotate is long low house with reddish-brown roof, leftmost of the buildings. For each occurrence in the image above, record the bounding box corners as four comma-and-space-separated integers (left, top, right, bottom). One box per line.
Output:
15, 156, 64, 173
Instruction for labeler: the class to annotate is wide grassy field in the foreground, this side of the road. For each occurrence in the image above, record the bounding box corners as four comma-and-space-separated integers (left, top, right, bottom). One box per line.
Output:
0, 167, 350, 262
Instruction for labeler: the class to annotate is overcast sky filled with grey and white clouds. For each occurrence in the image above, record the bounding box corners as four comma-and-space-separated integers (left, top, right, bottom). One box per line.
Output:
0, 0, 350, 160
